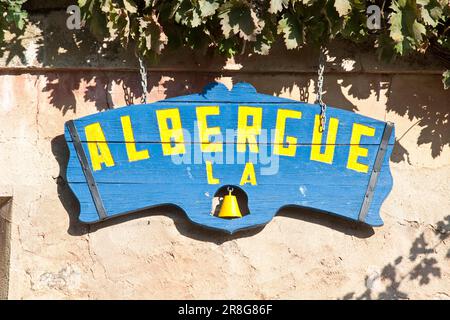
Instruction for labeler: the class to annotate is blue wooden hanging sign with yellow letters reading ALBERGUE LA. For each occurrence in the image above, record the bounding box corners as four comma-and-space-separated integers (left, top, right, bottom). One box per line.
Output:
65, 83, 394, 233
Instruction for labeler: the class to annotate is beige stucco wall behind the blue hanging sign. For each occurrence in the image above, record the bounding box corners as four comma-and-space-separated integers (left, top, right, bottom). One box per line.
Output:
0, 11, 450, 299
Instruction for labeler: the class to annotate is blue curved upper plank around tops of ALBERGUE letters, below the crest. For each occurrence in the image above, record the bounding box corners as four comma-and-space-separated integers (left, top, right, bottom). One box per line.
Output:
66, 101, 384, 145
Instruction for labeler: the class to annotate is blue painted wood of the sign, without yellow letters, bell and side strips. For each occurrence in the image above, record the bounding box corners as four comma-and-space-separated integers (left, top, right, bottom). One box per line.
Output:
65, 83, 395, 233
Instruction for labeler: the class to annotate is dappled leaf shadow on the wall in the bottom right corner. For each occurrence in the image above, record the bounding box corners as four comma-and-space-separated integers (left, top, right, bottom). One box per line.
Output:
343, 215, 450, 300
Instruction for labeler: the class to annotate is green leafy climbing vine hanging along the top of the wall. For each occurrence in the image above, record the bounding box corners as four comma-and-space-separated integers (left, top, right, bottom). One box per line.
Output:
0, 0, 450, 88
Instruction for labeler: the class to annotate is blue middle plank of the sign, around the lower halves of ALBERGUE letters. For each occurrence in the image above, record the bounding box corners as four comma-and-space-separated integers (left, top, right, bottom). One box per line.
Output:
68, 142, 386, 185
